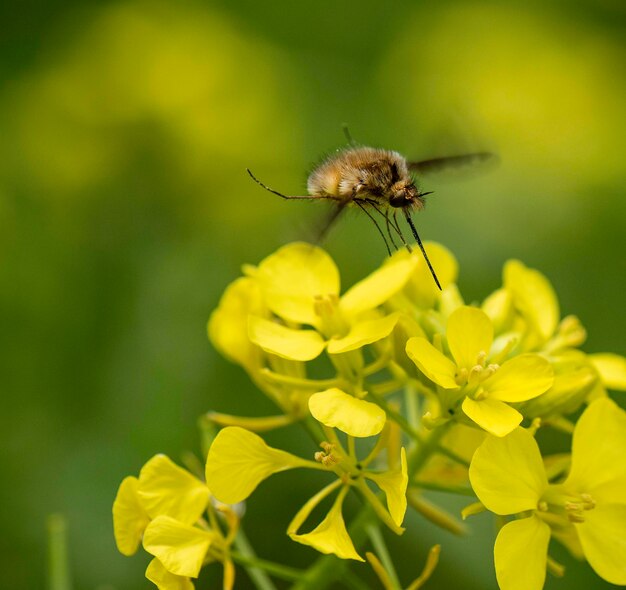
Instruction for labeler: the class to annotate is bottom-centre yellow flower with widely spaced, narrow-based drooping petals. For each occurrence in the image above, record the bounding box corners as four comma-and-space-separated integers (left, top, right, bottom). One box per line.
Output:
206, 428, 408, 560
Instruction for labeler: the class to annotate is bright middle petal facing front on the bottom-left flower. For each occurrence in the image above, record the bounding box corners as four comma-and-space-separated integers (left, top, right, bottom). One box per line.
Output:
143, 516, 216, 578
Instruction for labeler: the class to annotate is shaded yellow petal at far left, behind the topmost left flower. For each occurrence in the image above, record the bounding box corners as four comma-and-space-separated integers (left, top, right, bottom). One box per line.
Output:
208, 277, 267, 370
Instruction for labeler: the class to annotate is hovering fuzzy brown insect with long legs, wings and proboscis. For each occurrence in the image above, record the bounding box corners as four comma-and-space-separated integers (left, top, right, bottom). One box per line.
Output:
247, 130, 493, 290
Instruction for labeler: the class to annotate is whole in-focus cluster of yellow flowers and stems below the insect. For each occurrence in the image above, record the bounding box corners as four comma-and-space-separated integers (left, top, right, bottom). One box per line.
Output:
114, 243, 626, 590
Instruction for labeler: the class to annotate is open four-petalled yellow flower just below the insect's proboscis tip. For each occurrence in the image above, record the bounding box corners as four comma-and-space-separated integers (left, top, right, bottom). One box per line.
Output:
406, 306, 554, 436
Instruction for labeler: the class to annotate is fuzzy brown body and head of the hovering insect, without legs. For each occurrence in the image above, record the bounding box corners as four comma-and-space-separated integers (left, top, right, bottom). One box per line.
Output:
307, 147, 424, 209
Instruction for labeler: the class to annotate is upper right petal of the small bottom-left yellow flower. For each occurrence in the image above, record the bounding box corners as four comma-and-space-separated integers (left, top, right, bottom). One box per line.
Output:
137, 455, 209, 524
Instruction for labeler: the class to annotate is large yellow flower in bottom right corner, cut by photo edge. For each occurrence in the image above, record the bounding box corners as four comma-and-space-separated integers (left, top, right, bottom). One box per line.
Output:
470, 398, 626, 590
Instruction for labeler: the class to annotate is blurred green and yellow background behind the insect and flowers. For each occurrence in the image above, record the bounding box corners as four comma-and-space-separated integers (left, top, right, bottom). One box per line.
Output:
0, 0, 626, 590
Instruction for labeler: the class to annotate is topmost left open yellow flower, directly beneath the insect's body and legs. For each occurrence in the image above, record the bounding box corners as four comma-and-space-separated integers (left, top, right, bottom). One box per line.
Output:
248, 243, 416, 361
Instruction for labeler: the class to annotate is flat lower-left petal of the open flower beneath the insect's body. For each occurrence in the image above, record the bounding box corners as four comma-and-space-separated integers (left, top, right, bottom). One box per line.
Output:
248, 316, 326, 361
